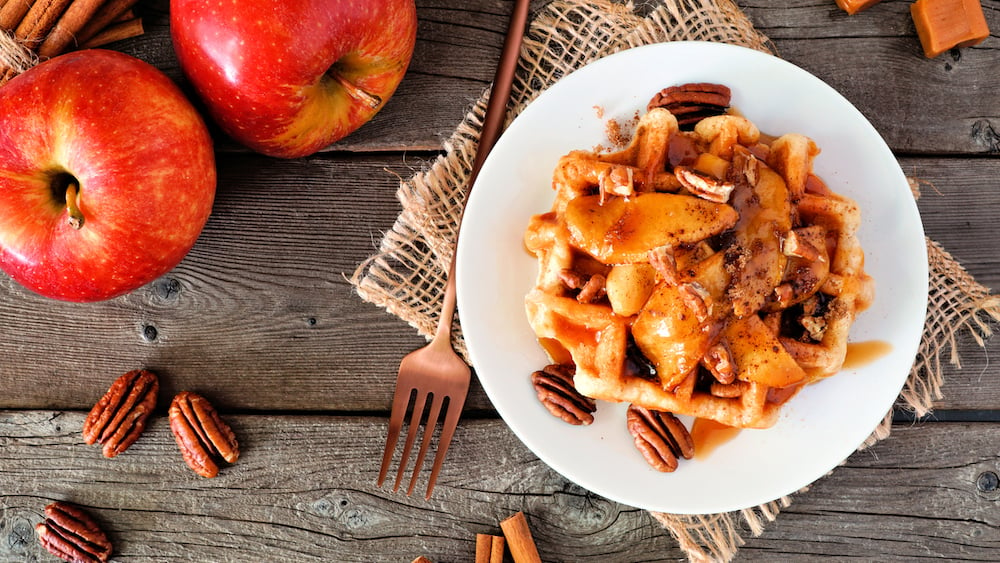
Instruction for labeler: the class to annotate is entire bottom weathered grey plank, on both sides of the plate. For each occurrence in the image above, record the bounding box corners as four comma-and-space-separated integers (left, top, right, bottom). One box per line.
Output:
0, 411, 1000, 562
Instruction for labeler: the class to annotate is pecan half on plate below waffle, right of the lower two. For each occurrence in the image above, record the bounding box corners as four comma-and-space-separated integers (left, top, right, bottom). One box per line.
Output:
625, 405, 694, 473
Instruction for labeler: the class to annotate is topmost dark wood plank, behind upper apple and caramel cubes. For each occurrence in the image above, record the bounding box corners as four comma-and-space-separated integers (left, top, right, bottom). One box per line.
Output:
114, 0, 1000, 154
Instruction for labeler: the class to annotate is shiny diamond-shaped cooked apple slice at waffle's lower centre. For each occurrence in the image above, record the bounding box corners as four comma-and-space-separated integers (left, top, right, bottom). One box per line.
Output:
632, 283, 713, 390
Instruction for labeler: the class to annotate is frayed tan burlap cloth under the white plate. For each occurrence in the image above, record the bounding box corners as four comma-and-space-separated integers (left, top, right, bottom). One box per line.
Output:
351, 0, 1000, 561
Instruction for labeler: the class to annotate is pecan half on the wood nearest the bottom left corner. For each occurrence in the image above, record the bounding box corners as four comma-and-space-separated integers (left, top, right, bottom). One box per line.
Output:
35, 502, 111, 563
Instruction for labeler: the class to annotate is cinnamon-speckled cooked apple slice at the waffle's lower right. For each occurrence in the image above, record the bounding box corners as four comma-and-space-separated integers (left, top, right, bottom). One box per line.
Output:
722, 315, 806, 387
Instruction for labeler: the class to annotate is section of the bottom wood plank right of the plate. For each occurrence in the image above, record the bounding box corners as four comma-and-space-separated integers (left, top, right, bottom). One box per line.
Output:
739, 423, 1000, 561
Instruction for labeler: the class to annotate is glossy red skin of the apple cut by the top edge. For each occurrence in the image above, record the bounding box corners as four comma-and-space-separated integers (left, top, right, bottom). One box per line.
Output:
170, 0, 417, 158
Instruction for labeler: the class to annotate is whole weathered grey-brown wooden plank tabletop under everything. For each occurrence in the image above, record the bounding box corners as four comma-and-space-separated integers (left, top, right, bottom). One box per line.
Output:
0, 0, 1000, 562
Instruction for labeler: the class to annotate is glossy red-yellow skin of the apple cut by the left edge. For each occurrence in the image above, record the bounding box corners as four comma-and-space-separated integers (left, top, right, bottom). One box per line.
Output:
0, 50, 215, 302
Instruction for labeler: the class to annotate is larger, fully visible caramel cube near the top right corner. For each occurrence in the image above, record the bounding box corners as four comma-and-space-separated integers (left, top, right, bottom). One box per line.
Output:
910, 0, 990, 58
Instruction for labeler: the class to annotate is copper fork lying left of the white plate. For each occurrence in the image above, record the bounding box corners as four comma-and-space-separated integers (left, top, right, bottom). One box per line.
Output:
378, 0, 528, 498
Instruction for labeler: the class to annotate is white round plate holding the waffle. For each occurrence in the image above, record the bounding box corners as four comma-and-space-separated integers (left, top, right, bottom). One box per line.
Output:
457, 42, 927, 514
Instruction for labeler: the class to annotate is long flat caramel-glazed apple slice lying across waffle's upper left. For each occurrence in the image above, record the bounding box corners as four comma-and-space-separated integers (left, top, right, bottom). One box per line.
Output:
565, 193, 739, 264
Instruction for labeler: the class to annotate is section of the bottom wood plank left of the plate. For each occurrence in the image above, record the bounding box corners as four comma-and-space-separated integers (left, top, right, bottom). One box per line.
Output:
0, 412, 679, 562
